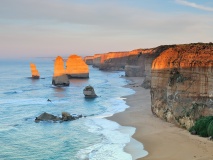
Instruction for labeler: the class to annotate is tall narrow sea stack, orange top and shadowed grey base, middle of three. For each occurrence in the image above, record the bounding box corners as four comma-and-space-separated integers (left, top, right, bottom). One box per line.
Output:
52, 56, 70, 86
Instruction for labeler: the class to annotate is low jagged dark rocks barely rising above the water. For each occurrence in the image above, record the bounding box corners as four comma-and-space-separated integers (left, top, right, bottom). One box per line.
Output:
35, 112, 83, 122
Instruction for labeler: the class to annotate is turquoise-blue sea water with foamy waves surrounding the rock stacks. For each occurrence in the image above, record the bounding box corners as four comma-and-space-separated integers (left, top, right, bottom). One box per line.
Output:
0, 58, 147, 160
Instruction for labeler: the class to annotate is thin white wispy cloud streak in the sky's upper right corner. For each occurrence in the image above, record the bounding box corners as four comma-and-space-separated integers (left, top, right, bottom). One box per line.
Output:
175, 0, 213, 12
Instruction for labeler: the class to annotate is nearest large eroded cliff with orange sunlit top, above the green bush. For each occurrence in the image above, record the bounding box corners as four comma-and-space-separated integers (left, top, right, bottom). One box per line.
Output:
150, 43, 213, 129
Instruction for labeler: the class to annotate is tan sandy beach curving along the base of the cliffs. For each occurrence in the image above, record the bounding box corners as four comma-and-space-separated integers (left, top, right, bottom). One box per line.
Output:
108, 77, 213, 160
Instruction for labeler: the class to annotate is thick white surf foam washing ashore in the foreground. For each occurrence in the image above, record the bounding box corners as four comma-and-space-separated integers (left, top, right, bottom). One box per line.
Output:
76, 117, 146, 160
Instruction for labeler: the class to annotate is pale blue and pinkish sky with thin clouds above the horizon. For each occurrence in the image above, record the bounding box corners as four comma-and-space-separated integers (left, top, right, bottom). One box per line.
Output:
0, 0, 213, 58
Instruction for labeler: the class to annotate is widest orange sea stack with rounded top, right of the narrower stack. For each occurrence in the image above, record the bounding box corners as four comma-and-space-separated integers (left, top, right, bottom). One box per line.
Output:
66, 55, 89, 78
